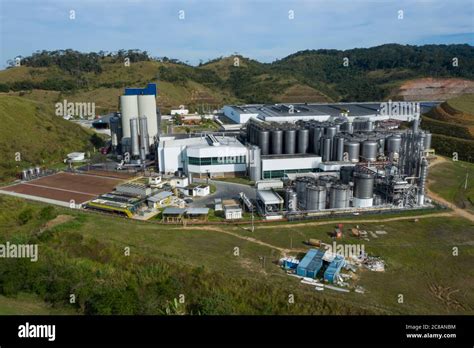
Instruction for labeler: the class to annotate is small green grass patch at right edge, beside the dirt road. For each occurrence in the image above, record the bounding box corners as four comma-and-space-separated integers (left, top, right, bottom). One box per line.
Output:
428, 158, 474, 212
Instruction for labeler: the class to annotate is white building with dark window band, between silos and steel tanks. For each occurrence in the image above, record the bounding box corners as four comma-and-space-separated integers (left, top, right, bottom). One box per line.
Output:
157, 135, 248, 178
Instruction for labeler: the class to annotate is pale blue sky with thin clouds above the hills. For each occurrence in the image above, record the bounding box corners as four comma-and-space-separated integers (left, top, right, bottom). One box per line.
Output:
0, 0, 474, 67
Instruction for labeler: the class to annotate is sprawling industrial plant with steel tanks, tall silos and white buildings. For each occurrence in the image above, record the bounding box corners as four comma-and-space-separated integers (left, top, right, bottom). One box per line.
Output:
3, 84, 433, 221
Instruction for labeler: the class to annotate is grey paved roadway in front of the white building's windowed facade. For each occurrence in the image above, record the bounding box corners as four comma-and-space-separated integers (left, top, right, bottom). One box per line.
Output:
189, 179, 256, 208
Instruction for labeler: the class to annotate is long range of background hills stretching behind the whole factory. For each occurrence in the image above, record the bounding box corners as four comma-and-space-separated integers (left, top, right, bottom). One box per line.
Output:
0, 44, 474, 113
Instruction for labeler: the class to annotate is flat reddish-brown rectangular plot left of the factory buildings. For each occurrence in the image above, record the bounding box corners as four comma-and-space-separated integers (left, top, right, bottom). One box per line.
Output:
2, 173, 122, 203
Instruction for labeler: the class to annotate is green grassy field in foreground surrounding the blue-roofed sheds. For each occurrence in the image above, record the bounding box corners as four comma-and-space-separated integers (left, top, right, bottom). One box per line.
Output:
0, 197, 474, 314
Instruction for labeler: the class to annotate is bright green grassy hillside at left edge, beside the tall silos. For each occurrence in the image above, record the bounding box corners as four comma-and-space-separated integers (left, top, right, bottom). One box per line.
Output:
0, 95, 93, 182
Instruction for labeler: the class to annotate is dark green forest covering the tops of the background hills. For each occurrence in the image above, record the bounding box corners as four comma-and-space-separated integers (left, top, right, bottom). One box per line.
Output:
0, 44, 474, 103
